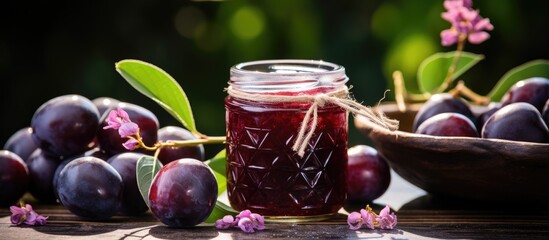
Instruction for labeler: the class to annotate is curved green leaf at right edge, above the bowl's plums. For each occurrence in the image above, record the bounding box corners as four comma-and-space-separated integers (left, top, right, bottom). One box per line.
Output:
488, 59, 549, 102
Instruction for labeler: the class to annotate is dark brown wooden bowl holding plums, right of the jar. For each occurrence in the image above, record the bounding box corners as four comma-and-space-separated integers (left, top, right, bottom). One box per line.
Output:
354, 103, 549, 206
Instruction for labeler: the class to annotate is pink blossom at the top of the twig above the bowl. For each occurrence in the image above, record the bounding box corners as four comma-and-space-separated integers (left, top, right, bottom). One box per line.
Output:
440, 0, 494, 46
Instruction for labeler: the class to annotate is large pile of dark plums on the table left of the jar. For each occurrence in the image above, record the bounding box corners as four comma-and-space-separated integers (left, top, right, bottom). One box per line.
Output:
0, 95, 217, 225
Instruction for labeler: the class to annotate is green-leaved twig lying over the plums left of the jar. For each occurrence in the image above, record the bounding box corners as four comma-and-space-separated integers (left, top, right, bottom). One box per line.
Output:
115, 59, 231, 223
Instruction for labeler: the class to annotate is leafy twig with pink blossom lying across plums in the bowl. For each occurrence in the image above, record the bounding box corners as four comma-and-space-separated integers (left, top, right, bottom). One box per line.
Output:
393, 0, 549, 111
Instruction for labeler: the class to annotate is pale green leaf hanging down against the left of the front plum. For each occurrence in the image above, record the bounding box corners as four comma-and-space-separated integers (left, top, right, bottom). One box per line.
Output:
135, 156, 162, 207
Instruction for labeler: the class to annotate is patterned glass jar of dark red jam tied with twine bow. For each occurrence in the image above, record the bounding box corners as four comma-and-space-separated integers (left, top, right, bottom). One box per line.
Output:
225, 60, 348, 222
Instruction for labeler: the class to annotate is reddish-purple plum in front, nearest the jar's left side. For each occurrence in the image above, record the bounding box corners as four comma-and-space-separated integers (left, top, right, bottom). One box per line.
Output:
149, 158, 217, 228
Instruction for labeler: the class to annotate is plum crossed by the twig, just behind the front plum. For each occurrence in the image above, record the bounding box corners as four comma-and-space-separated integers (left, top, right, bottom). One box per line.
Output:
158, 126, 205, 165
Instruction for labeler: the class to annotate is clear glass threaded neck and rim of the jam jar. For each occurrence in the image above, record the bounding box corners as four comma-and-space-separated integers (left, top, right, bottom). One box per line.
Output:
229, 60, 349, 95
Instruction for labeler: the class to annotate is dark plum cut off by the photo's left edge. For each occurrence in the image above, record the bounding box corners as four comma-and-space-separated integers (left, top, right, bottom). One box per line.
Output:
0, 150, 30, 207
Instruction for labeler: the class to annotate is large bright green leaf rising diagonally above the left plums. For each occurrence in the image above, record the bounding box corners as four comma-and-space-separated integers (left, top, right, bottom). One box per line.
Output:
115, 59, 196, 132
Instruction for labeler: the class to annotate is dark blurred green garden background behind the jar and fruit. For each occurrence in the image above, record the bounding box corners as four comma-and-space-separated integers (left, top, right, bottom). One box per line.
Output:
0, 0, 549, 156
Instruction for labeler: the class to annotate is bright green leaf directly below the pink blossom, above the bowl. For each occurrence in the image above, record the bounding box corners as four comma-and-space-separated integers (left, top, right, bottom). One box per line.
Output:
417, 51, 484, 93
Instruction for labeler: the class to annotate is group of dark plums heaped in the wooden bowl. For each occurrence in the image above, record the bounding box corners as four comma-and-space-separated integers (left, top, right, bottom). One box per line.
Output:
413, 77, 549, 143
